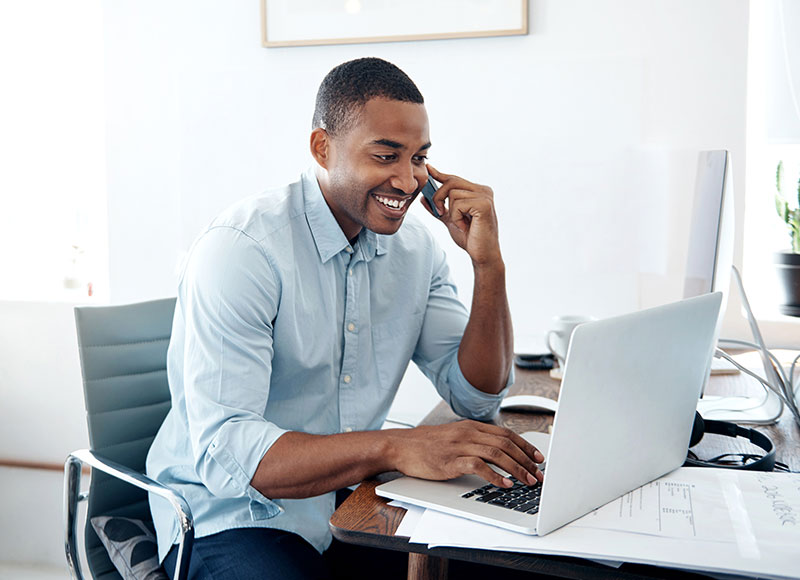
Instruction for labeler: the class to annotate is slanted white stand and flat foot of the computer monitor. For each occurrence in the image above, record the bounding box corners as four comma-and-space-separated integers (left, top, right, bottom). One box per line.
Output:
697, 266, 783, 425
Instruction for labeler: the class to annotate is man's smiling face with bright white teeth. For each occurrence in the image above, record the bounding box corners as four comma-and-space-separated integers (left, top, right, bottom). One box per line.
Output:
321, 99, 430, 239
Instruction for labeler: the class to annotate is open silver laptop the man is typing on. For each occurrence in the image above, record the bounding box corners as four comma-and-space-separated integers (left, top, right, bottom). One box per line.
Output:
375, 292, 722, 535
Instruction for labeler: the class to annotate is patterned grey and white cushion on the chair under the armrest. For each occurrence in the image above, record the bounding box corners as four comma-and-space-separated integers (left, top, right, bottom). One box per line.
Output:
91, 516, 169, 580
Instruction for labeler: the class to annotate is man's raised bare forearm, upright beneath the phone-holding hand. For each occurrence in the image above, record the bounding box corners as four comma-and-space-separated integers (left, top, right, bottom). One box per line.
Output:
458, 259, 514, 393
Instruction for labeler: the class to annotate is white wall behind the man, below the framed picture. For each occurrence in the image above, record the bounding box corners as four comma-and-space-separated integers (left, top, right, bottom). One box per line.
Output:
105, 0, 747, 348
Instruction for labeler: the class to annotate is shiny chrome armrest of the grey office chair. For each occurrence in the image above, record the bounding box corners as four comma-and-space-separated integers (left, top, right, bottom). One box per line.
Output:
64, 449, 194, 580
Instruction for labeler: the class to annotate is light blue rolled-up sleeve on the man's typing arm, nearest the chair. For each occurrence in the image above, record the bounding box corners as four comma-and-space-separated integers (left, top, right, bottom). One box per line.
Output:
179, 227, 286, 516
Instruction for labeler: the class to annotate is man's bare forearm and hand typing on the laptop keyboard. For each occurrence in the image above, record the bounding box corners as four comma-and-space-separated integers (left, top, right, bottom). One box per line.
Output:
250, 421, 544, 499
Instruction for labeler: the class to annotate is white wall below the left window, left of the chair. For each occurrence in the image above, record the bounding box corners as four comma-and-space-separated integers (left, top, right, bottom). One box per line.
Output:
0, 301, 88, 577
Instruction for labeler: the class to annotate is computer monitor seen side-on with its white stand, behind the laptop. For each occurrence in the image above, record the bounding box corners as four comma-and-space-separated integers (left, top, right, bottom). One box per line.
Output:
683, 150, 783, 423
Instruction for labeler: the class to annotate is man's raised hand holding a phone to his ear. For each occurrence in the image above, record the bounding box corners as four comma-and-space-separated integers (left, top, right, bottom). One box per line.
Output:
421, 165, 502, 265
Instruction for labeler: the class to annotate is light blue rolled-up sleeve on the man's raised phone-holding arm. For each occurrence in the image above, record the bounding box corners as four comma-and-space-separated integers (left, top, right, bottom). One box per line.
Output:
412, 245, 514, 420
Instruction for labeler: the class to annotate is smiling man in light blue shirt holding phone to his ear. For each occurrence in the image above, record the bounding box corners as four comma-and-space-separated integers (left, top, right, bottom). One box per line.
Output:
147, 58, 543, 578
